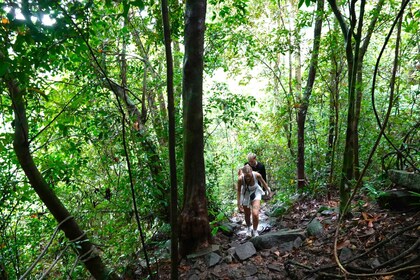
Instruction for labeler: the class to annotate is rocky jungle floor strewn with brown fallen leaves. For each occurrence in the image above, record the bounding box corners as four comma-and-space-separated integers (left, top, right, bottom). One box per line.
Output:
135, 192, 420, 280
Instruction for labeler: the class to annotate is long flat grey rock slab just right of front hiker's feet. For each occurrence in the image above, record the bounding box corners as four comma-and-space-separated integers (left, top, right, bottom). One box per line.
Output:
250, 229, 305, 250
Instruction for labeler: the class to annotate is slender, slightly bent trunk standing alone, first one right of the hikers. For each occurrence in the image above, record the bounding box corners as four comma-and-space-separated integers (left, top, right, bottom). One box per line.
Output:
297, 0, 324, 189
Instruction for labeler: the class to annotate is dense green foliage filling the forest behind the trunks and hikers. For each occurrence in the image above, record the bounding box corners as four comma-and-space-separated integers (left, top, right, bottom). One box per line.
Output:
0, 0, 420, 279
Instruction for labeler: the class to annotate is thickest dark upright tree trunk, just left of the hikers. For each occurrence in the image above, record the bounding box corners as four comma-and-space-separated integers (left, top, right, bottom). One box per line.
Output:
180, 0, 211, 256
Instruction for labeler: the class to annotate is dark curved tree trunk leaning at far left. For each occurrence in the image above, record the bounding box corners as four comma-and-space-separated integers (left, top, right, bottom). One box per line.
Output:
7, 81, 118, 279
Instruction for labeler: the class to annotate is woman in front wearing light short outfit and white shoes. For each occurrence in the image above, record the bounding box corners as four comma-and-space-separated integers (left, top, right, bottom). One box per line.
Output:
237, 165, 272, 237
